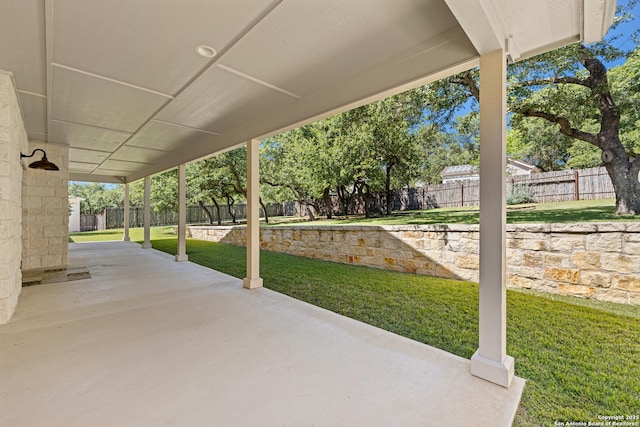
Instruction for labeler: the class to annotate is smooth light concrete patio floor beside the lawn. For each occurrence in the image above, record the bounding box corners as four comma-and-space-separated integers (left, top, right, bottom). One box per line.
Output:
0, 242, 524, 427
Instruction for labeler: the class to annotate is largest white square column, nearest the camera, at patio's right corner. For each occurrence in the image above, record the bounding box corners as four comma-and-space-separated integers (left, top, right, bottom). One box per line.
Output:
471, 49, 513, 387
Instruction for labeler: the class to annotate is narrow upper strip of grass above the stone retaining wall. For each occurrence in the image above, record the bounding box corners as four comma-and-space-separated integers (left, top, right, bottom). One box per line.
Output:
275, 199, 640, 225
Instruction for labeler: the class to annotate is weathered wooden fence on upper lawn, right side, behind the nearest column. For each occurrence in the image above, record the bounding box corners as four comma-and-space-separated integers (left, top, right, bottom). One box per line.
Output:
393, 167, 615, 210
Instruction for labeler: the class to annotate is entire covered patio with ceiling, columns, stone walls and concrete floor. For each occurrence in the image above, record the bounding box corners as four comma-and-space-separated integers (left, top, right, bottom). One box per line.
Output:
0, 0, 616, 425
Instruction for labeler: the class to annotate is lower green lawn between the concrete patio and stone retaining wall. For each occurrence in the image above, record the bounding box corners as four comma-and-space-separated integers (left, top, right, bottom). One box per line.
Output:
72, 227, 640, 426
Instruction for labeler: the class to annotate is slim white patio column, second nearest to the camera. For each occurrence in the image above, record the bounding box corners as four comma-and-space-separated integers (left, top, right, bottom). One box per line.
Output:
242, 139, 262, 289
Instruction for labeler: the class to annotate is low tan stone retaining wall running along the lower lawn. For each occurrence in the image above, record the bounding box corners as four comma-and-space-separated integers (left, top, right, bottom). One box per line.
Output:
187, 223, 640, 304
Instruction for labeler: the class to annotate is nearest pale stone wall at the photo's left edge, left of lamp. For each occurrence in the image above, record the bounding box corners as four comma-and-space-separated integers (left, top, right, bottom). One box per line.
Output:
0, 71, 27, 323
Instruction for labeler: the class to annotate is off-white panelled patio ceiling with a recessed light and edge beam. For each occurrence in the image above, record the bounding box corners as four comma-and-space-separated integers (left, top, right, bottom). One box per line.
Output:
0, 0, 615, 182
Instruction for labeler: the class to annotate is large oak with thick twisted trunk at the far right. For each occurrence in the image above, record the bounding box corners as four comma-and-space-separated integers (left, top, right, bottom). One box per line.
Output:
427, 0, 640, 215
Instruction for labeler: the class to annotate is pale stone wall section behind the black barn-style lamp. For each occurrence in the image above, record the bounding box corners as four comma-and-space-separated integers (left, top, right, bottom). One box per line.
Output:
22, 141, 69, 272
